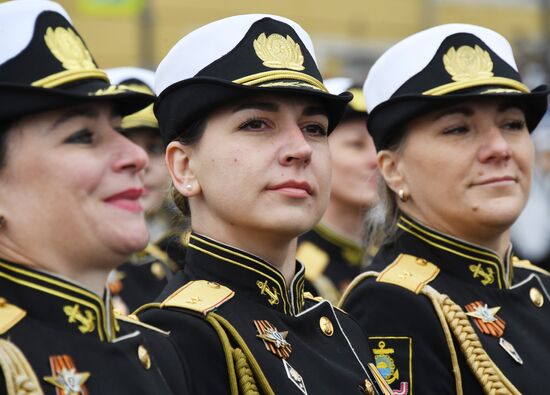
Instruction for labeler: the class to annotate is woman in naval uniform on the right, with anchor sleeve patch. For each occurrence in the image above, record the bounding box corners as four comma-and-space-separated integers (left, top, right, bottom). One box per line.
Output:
342, 24, 550, 395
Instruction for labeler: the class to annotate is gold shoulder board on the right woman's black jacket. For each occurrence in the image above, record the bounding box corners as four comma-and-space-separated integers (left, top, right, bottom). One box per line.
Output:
376, 254, 439, 294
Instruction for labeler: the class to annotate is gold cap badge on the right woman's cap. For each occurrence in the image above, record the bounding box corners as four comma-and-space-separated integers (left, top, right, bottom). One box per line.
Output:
443, 45, 493, 82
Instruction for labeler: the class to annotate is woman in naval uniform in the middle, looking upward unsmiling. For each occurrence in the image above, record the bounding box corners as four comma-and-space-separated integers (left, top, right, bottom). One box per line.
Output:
136, 15, 391, 395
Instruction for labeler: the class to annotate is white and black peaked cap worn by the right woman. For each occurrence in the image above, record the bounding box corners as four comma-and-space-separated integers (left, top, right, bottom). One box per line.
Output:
363, 24, 548, 150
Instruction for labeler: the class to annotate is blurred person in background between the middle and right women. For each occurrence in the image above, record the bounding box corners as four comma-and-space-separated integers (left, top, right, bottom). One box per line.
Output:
296, 77, 378, 303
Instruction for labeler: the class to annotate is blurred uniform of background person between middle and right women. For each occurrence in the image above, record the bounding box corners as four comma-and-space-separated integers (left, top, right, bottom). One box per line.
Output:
296, 224, 364, 303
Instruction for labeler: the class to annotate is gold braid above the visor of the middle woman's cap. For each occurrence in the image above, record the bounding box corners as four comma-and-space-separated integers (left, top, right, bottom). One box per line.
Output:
233, 70, 328, 93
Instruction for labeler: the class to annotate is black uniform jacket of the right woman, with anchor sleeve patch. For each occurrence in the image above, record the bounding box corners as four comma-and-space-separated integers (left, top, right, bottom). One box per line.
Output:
342, 216, 550, 395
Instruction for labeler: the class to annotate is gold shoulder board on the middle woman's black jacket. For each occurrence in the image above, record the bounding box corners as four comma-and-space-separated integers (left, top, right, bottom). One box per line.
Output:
160, 280, 235, 315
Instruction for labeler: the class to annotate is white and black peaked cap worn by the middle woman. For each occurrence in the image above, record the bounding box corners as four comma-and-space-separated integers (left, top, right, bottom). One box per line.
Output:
155, 14, 352, 143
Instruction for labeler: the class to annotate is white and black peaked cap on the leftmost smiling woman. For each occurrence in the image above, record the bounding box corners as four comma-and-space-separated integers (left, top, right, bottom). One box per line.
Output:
0, 0, 153, 122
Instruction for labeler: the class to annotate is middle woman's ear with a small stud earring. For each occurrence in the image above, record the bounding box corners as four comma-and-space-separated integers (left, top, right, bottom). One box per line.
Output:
166, 141, 201, 197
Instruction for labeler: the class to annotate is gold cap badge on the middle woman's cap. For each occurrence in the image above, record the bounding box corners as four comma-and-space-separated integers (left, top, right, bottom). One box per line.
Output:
254, 33, 304, 71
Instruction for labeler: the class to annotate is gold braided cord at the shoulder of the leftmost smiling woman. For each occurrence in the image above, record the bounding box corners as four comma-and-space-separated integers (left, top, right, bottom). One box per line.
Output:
0, 339, 44, 395
